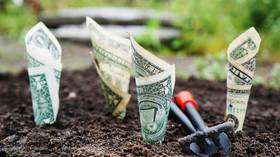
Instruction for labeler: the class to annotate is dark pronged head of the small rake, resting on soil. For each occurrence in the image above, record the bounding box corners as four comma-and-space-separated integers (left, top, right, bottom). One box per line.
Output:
179, 122, 233, 156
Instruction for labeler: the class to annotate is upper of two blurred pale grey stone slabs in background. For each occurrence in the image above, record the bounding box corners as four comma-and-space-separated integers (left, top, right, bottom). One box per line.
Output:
39, 7, 179, 27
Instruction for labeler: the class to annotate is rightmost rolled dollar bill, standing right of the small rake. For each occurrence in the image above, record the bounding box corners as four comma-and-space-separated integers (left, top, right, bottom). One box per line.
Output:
225, 27, 261, 131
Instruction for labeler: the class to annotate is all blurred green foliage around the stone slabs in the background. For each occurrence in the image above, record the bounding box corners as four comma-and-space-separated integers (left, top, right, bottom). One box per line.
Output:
0, 0, 280, 61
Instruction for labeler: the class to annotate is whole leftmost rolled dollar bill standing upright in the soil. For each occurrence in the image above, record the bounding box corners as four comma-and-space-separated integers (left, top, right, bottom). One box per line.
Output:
25, 22, 62, 125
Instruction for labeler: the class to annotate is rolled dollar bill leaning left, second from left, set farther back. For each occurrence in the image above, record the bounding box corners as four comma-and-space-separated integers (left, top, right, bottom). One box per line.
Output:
86, 17, 132, 119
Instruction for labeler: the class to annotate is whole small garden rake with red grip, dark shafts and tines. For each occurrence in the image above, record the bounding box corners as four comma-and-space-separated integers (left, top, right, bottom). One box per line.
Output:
171, 91, 233, 156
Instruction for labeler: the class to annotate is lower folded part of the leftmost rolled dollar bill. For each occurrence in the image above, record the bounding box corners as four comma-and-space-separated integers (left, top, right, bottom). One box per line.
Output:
28, 66, 58, 124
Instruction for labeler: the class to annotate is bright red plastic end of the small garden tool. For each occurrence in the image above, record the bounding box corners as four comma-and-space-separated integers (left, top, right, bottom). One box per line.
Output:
175, 91, 198, 112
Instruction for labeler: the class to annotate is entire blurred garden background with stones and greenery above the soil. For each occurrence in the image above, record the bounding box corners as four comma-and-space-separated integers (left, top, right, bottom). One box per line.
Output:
0, 0, 280, 88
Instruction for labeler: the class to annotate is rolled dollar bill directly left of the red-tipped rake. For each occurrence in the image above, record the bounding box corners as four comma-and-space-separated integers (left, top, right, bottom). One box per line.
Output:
130, 36, 175, 143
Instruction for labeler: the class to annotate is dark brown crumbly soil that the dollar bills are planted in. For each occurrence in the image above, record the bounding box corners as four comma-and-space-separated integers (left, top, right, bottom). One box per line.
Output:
0, 69, 280, 156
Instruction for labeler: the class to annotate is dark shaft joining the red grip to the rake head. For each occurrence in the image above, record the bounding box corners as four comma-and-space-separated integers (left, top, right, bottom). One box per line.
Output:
185, 103, 208, 131
